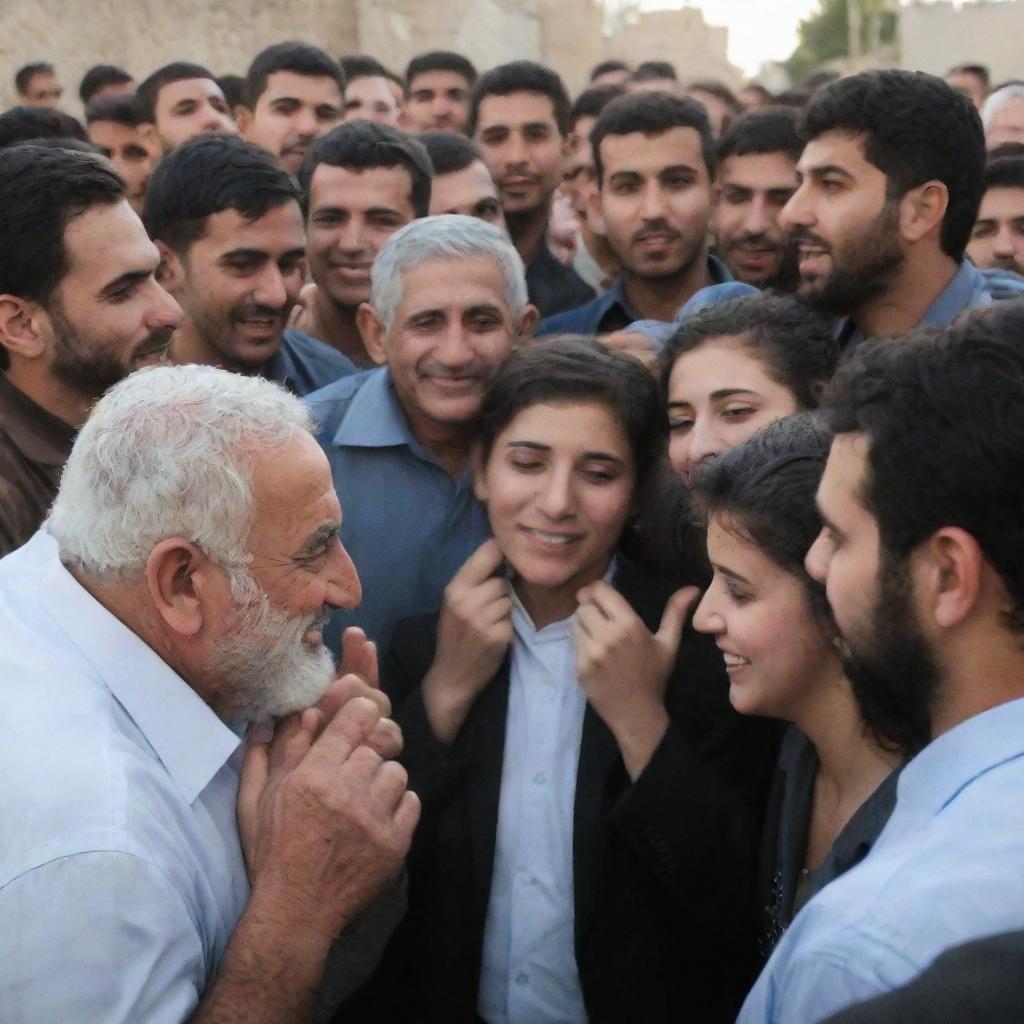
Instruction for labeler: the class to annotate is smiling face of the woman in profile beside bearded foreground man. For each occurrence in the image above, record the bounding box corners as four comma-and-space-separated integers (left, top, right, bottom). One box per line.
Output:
693, 516, 837, 722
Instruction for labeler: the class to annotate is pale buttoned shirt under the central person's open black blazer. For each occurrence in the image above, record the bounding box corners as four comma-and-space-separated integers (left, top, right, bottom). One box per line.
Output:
477, 586, 587, 1024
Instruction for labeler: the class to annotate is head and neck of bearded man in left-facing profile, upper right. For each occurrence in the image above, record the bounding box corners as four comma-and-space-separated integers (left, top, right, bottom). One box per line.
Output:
780, 71, 992, 344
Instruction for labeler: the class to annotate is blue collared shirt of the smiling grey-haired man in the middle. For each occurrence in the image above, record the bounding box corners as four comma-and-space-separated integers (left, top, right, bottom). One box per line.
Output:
307, 367, 490, 652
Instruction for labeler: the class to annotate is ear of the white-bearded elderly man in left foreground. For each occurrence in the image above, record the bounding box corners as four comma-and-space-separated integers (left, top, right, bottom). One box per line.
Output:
145, 537, 221, 637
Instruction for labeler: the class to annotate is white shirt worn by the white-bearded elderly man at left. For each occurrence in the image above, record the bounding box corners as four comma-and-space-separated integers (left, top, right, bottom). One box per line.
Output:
0, 531, 249, 1024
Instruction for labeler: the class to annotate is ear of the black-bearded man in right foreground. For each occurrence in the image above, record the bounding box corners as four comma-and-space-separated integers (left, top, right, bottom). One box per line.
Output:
918, 526, 985, 630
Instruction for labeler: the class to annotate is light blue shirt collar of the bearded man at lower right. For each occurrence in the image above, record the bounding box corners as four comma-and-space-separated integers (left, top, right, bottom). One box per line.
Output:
893, 697, 1024, 821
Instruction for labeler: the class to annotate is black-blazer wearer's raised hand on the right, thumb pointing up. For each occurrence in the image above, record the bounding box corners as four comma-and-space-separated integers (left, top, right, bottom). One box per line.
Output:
573, 581, 698, 778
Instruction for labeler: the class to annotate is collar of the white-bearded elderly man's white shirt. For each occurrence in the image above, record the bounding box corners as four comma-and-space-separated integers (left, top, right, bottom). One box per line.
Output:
29, 531, 241, 804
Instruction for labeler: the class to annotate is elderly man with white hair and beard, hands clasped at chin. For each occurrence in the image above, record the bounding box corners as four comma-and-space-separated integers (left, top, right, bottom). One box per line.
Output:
0, 366, 419, 1024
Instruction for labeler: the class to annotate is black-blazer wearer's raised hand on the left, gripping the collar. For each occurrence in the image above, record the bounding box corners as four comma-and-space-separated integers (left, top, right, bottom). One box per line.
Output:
423, 540, 512, 743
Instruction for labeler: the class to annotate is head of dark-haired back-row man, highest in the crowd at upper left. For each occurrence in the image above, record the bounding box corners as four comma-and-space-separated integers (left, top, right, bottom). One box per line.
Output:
240, 43, 345, 174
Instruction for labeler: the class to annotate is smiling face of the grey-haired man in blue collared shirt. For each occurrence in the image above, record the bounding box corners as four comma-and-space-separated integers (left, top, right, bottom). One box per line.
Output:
368, 256, 531, 436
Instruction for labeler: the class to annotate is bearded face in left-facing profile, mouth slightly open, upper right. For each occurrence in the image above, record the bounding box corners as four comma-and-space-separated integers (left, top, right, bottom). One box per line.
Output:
779, 130, 904, 314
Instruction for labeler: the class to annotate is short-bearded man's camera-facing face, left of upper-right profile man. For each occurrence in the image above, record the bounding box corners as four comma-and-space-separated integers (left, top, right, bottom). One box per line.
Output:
591, 128, 712, 279
